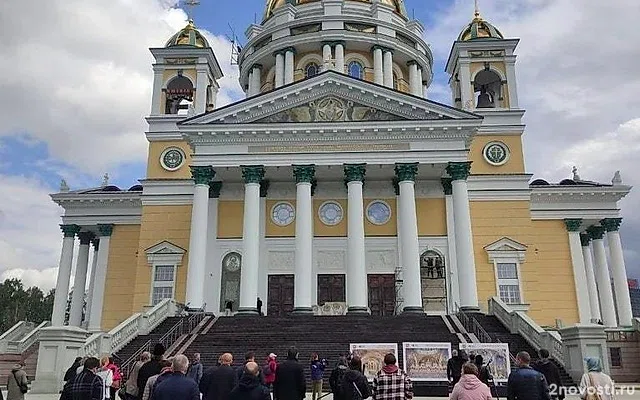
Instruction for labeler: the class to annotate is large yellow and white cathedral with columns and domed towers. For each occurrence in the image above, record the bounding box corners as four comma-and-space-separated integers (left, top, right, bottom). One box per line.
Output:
52, 0, 632, 331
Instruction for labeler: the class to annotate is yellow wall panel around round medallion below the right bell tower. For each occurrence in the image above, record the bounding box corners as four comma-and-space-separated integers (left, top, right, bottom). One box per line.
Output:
469, 135, 525, 174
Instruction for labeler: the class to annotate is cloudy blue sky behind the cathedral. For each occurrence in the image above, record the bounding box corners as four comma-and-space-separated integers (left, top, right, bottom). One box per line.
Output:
0, 0, 640, 290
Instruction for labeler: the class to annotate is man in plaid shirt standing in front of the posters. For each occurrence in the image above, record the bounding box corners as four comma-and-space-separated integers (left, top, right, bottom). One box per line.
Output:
372, 353, 413, 400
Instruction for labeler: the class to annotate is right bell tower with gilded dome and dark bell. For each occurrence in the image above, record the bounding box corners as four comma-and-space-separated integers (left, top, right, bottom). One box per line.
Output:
446, 0, 519, 111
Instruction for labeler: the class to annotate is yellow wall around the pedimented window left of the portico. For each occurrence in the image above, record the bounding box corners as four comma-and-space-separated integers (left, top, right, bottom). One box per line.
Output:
133, 205, 191, 311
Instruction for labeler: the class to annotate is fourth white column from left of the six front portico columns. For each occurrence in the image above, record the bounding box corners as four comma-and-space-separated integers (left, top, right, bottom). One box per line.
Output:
344, 164, 369, 314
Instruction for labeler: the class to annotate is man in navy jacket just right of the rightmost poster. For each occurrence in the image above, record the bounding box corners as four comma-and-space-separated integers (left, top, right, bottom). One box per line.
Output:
507, 351, 551, 400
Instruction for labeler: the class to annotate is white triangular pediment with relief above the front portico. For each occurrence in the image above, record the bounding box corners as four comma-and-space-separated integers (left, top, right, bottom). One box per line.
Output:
180, 71, 482, 126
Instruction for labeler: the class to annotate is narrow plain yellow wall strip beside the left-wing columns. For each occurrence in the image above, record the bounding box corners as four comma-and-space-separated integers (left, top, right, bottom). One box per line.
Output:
101, 225, 140, 331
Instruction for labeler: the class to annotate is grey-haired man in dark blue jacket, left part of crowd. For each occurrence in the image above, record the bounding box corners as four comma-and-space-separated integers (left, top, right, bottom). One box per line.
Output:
153, 354, 200, 400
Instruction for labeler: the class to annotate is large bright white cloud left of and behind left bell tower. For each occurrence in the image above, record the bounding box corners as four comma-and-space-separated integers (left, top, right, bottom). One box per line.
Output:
0, 0, 240, 174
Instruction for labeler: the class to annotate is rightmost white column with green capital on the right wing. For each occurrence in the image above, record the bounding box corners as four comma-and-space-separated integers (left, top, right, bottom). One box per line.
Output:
601, 218, 633, 326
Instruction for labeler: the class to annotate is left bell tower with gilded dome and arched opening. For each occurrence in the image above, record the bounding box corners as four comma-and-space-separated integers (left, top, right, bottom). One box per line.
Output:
150, 19, 223, 117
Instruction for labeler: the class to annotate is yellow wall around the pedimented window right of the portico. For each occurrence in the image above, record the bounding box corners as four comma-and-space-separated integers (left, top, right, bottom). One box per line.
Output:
470, 201, 578, 326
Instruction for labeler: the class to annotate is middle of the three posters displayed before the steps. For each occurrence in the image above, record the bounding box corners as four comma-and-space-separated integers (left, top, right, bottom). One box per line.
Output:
402, 342, 451, 382
